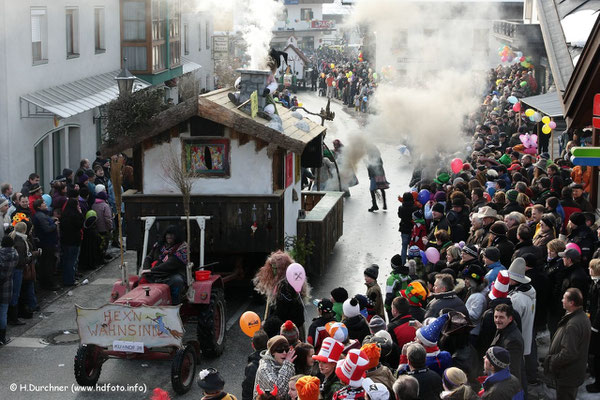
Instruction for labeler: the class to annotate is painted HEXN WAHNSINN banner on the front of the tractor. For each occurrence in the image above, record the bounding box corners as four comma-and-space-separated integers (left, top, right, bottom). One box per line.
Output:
75, 304, 184, 352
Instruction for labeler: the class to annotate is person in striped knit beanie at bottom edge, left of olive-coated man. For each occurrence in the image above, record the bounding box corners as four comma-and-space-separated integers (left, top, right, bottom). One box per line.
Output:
480, 346, 524, 400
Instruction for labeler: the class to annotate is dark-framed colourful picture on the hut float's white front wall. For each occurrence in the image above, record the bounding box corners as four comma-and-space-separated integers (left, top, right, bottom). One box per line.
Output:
183, 138, 230, 176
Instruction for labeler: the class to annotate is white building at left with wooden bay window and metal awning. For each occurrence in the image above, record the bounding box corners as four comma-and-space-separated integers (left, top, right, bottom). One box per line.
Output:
0, 0, 202, 191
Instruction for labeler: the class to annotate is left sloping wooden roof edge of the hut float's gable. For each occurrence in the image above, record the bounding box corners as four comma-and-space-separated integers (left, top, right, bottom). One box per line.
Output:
100, 97, 198, 155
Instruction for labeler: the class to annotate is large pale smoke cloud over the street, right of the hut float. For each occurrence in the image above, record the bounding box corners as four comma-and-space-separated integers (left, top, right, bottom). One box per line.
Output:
332, 0, 497, 175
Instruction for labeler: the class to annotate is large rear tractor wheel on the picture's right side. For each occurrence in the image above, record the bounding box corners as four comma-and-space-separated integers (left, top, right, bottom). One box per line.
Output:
197, 288, 226, 358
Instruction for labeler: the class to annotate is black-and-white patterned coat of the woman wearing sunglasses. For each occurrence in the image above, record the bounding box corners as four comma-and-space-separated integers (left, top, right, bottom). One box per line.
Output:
252, 350, 296, 400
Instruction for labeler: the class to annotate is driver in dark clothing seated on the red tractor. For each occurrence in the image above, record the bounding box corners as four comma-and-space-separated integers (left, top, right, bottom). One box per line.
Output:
140, 225, 188, 305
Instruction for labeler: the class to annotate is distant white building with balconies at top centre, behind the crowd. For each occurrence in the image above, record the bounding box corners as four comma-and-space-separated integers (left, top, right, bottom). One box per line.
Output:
271, 0, 336, 52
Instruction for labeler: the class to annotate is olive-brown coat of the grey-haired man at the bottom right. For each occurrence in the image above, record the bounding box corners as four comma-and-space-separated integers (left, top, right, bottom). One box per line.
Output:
544, 308, 592, 387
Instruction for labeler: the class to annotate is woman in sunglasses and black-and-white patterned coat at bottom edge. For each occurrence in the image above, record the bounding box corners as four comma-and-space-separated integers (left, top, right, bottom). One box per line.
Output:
253, 335, 296, 399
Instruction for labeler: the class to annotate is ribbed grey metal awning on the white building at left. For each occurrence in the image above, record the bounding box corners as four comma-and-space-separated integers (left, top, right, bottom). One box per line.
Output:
21, 70, 150, 118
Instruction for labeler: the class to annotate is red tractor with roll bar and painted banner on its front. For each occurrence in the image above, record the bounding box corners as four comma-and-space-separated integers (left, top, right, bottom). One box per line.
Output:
74, 216, 225, 394
